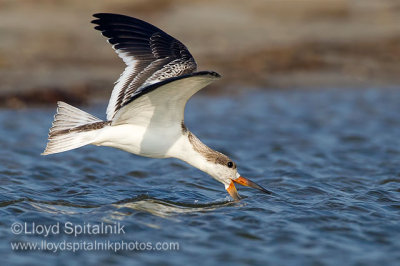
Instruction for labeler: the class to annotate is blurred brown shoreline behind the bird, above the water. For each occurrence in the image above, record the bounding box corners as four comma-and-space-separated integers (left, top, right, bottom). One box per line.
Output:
0, 0, 400, 108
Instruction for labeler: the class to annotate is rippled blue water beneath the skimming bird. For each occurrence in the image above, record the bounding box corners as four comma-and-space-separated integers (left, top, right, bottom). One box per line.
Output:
0, 90, 400, 265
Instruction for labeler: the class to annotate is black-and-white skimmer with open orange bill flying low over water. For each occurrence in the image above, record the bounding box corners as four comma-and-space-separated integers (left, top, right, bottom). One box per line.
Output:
42, 13, 271, 201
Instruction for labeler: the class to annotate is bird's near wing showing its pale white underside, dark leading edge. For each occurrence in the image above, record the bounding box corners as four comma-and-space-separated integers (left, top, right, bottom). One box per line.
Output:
112, 71, 221, 127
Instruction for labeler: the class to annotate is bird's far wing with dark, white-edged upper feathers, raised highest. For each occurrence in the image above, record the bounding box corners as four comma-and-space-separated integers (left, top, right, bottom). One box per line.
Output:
92, 13, 197, 120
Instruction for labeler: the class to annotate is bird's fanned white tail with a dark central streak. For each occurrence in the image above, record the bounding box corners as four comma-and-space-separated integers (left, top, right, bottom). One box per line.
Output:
42, 102, 109, 155
